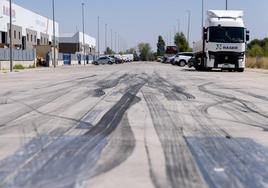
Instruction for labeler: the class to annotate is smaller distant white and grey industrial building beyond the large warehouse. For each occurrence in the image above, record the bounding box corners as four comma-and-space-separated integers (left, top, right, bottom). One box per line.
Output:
59, 32, 96, 54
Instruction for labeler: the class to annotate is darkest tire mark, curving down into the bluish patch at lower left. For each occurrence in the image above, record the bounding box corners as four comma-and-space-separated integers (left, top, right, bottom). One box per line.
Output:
0, 74, 145, 188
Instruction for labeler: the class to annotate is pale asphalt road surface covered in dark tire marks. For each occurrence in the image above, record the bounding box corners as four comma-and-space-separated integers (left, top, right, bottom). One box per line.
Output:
0, 62, 268, 188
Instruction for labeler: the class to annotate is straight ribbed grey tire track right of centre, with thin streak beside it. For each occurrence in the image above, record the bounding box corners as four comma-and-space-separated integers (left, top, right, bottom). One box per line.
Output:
142, 92, 204, 188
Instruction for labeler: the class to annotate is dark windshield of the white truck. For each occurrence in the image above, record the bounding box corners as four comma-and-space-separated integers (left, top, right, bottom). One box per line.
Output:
209, 27, 245, 43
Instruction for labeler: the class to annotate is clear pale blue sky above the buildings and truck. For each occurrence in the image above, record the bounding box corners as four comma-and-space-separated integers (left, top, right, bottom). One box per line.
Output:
13, 0, 268, 50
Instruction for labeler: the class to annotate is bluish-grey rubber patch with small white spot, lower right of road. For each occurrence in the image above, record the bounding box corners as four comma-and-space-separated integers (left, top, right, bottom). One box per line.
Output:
187, 137, 268, 188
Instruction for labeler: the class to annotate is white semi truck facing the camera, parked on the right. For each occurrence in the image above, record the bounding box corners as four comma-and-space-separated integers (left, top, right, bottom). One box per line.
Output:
192, 10, 249, 72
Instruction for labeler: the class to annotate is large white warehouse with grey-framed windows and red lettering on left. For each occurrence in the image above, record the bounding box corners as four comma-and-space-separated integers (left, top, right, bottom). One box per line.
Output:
0, 0, 59, 50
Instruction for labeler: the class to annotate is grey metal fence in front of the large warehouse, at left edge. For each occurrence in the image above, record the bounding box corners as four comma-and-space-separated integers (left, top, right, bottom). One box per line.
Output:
0, 48, 35, 61
